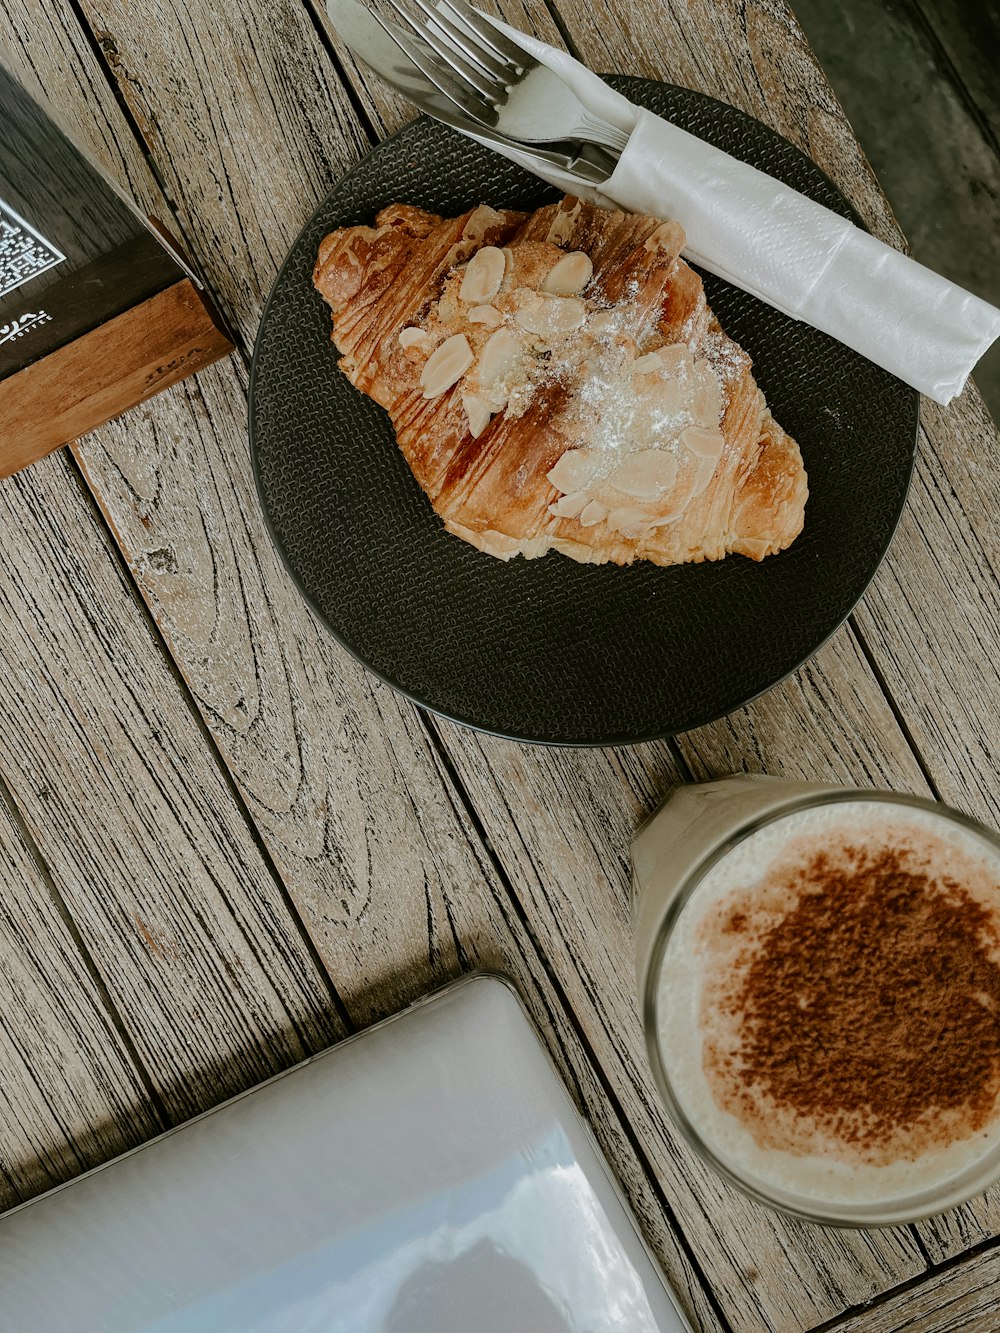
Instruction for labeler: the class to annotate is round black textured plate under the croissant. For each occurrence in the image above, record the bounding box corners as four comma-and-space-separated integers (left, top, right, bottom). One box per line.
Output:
251, 77, 919, 745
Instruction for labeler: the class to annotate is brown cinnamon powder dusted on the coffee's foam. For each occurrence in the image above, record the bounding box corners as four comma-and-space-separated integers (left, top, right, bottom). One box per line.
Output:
701, 837, 1000, 1165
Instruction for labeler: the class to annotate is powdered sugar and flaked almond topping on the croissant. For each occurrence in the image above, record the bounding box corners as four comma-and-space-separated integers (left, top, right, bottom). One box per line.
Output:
413, 231, 748, 536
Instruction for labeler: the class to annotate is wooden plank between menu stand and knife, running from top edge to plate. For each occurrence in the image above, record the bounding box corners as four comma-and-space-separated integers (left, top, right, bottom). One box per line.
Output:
67, 0, 368, 349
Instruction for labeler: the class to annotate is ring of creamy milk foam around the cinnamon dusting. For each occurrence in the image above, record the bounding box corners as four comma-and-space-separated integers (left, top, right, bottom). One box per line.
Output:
656, 800, 1000, 1213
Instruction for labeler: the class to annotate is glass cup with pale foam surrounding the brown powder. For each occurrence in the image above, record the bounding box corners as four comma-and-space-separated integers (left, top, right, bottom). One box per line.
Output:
632, 776, 1000, 1226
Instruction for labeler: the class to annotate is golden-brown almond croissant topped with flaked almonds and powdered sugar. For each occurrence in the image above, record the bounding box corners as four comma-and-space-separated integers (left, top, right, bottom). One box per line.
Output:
315, 197, 807, 565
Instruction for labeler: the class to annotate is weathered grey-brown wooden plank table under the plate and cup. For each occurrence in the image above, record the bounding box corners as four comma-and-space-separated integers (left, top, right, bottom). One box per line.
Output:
0, 0, 1000, 1333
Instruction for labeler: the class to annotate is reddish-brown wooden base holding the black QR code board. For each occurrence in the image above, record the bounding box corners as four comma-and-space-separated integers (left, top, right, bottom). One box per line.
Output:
0, 224, 232, 477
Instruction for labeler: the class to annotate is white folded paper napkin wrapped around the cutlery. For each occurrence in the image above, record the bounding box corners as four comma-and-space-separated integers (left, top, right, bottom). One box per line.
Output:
472, 16, 1000, 404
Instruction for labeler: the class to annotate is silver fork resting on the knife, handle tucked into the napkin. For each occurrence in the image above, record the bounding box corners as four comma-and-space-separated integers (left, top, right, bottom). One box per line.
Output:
373, 0, 628, 153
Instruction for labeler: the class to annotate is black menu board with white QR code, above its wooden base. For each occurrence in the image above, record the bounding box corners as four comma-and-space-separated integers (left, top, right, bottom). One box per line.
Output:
0, 65, 191, 380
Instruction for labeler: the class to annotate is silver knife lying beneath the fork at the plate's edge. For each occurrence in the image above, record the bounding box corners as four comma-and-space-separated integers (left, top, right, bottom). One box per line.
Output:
327, 0, 613, 185
